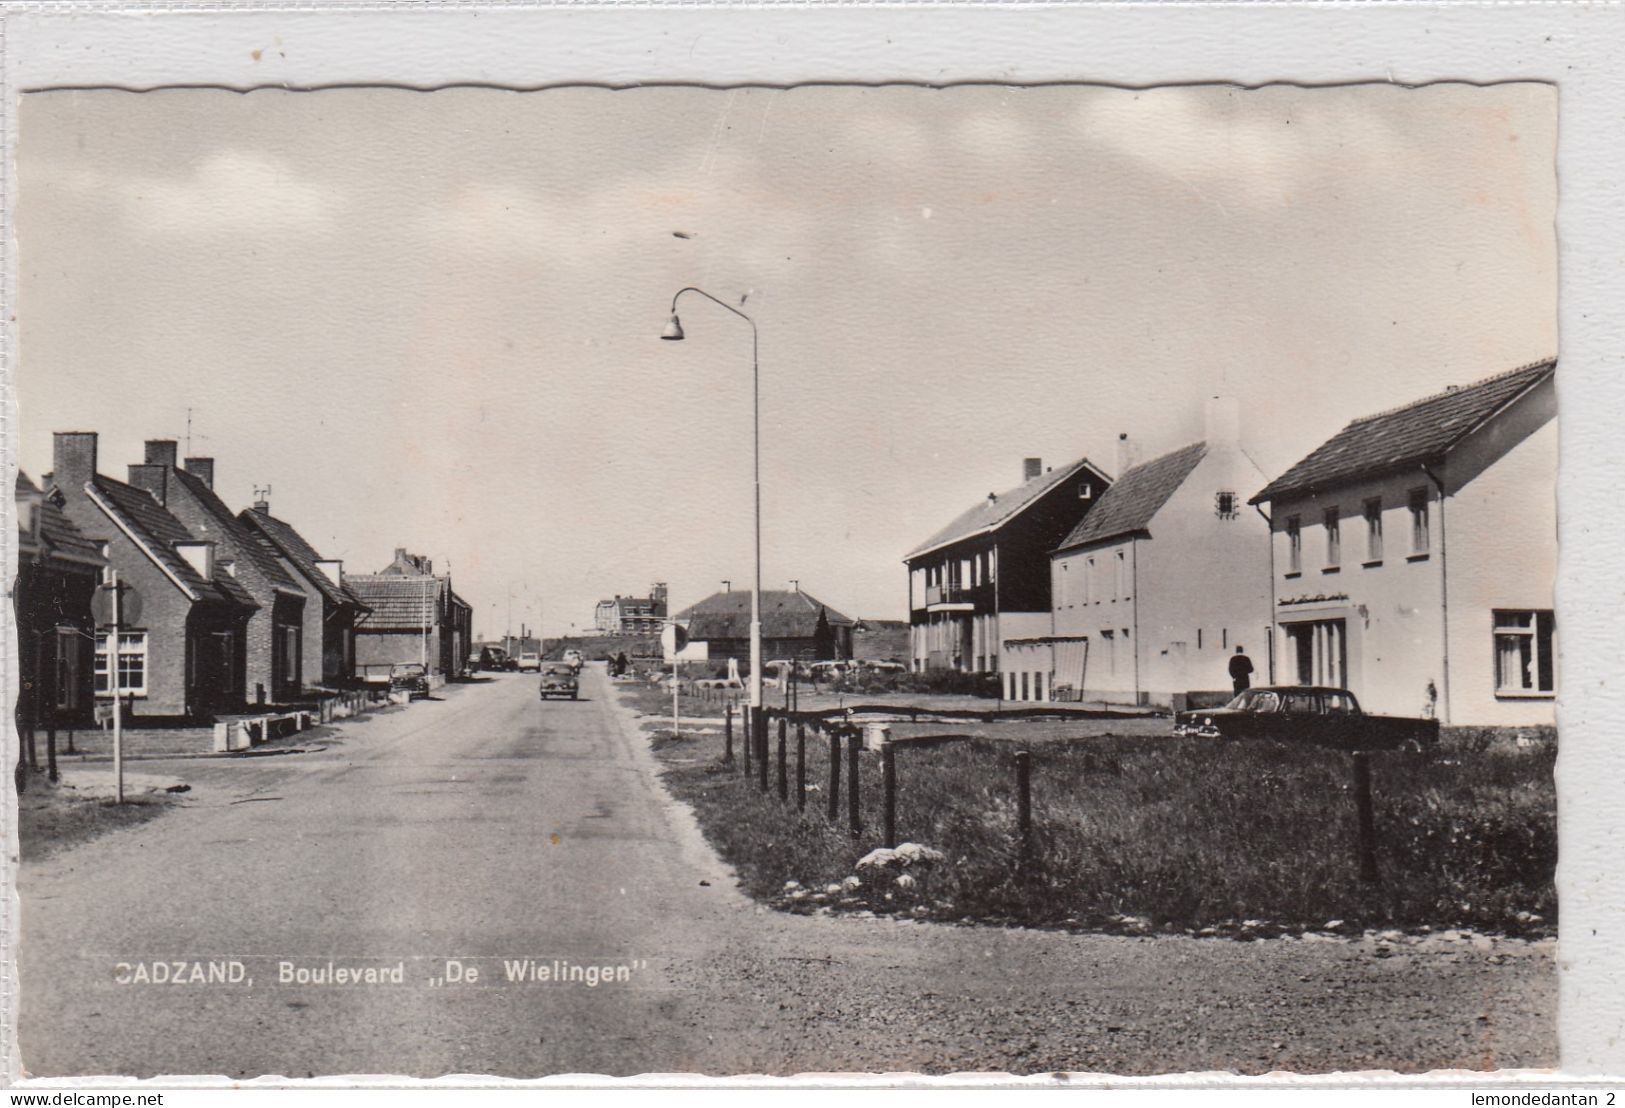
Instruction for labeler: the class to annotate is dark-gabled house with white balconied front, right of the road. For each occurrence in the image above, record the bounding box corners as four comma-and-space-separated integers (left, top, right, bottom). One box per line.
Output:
904, 458, 1112, 674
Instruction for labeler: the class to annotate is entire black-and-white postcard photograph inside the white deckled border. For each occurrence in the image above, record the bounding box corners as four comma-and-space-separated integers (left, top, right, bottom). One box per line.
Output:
8, 2, 1599, 1080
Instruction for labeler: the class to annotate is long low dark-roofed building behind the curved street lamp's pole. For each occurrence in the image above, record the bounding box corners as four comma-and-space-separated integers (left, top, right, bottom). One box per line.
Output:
673, 588, 856, 663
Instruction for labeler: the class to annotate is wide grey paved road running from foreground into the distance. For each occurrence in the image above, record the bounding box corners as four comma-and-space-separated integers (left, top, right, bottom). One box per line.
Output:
20, 669, 1555, 1077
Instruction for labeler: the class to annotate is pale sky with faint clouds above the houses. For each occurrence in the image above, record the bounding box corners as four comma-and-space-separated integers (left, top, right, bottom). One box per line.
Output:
16, 84, 1557, 635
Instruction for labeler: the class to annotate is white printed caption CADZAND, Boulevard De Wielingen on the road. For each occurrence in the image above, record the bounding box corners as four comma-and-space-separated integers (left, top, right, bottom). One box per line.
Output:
112, 957, 648, 989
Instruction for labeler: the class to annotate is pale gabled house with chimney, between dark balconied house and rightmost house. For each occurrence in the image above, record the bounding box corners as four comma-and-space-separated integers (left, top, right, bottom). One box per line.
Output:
1033, 400, 1269, 707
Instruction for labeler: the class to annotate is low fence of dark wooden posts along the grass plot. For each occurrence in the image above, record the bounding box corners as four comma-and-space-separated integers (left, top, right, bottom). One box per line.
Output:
722, 705, 1380, 884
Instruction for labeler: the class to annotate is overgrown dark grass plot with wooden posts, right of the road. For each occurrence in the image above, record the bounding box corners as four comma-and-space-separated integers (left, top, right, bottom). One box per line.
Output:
637, 688, 1557, 934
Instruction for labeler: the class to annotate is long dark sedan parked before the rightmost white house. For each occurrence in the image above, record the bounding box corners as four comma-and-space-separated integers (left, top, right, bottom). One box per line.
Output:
1173, 686, 1438, 751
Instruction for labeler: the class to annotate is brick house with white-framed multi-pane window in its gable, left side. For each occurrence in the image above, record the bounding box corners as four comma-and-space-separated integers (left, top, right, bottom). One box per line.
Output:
49, 431, 258, 718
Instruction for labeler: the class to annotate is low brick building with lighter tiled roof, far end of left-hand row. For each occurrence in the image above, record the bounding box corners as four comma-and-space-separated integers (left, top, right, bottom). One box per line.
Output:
354, 548, 475, 676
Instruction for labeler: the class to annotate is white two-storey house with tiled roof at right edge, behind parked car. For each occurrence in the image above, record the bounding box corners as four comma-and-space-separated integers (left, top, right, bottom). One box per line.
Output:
1253, 361, 1560, 725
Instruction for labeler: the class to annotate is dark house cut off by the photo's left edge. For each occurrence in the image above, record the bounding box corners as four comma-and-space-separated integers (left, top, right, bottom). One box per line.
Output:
11, 473, 107, 734
